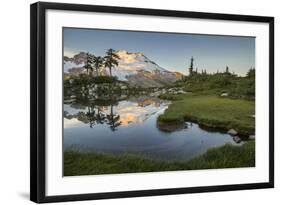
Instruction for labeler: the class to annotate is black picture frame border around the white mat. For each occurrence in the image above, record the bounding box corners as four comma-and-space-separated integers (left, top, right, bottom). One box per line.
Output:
30, 2, 274, 203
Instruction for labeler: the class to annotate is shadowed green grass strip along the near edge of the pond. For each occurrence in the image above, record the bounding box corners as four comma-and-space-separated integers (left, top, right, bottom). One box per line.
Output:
64, 141, 255, 176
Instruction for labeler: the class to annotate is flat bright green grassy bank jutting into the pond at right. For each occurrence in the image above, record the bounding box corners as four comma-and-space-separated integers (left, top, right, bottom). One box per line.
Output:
157, 94, 255, 135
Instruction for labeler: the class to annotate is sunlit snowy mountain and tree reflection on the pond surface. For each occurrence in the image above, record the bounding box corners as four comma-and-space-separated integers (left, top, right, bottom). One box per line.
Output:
64, 98, 168, 131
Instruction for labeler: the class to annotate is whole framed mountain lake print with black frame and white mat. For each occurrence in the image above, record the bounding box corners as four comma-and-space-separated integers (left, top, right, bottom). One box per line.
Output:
30, 2, 274, 203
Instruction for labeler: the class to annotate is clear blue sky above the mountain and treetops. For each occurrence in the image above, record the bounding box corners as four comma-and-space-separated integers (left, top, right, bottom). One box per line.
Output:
63, 28, 255, 76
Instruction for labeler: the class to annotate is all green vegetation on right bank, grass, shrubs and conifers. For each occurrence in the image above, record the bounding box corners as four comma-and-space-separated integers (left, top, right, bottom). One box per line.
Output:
157, 63, 255, 135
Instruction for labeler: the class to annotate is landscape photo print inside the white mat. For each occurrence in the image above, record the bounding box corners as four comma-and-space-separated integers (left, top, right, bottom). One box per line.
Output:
62, 28, 255, 176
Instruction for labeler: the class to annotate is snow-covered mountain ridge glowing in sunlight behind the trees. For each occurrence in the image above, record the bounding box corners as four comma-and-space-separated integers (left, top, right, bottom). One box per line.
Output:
63, 50, 183, 87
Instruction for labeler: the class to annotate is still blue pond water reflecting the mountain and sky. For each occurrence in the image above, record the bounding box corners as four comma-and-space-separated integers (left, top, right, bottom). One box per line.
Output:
64, 97, 243, 160
